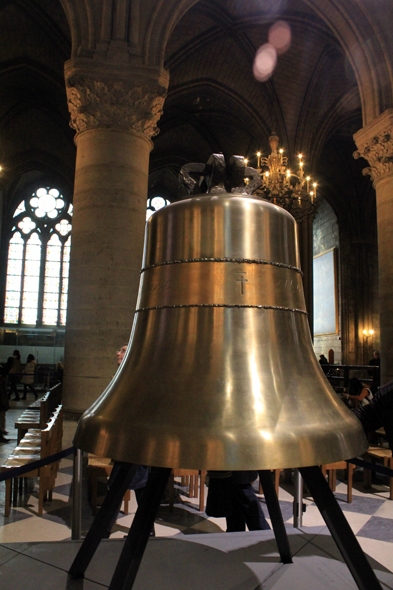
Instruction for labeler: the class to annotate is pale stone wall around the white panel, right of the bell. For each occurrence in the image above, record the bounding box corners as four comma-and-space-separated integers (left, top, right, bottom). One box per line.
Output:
313, 198, 342, 364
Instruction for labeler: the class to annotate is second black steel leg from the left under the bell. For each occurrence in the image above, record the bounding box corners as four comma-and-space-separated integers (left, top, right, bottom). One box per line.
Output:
109, 467, 172, 590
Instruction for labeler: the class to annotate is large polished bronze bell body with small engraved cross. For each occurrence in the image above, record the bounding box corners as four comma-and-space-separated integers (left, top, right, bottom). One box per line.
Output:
74, 193, 367, 470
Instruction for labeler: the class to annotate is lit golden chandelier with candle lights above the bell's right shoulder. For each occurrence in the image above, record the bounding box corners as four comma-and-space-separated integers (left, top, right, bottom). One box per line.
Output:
246, 133, 317, 221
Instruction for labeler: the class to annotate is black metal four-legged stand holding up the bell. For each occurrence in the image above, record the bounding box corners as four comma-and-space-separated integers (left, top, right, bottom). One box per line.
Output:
69, 464, 382, 590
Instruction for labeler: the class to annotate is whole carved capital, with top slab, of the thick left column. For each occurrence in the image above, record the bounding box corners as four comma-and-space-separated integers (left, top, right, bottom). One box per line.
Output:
65, 59, 169, 139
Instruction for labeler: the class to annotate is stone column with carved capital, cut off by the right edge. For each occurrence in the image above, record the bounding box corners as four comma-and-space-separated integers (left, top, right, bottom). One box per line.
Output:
354, 109, 393, 385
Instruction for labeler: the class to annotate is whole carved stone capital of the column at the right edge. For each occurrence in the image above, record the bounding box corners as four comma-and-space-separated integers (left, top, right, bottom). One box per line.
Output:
353, 109, 393, 183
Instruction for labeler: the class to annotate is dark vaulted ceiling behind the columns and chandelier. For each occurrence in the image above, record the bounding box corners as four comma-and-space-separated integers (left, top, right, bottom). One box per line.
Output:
0, 0, 375, 234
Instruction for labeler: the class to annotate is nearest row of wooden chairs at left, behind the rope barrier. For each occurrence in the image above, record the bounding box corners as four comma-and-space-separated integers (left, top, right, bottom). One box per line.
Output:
1, 405, 63, 516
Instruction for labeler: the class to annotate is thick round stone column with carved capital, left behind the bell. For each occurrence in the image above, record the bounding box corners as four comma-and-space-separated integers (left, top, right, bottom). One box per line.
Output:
64, 59, 169, 414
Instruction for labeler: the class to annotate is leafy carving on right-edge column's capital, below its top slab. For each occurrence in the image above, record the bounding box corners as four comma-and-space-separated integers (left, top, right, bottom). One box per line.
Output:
353, 129, 393, 182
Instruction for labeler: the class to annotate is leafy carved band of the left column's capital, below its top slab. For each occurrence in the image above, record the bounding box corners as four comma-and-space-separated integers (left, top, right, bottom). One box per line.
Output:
66, 75, 166, 139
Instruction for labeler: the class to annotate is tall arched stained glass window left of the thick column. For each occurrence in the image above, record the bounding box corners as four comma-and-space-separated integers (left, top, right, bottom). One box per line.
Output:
4, 187, 72, 326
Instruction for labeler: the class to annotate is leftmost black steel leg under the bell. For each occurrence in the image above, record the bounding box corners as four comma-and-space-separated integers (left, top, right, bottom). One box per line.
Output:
68, 463, 138, 578
